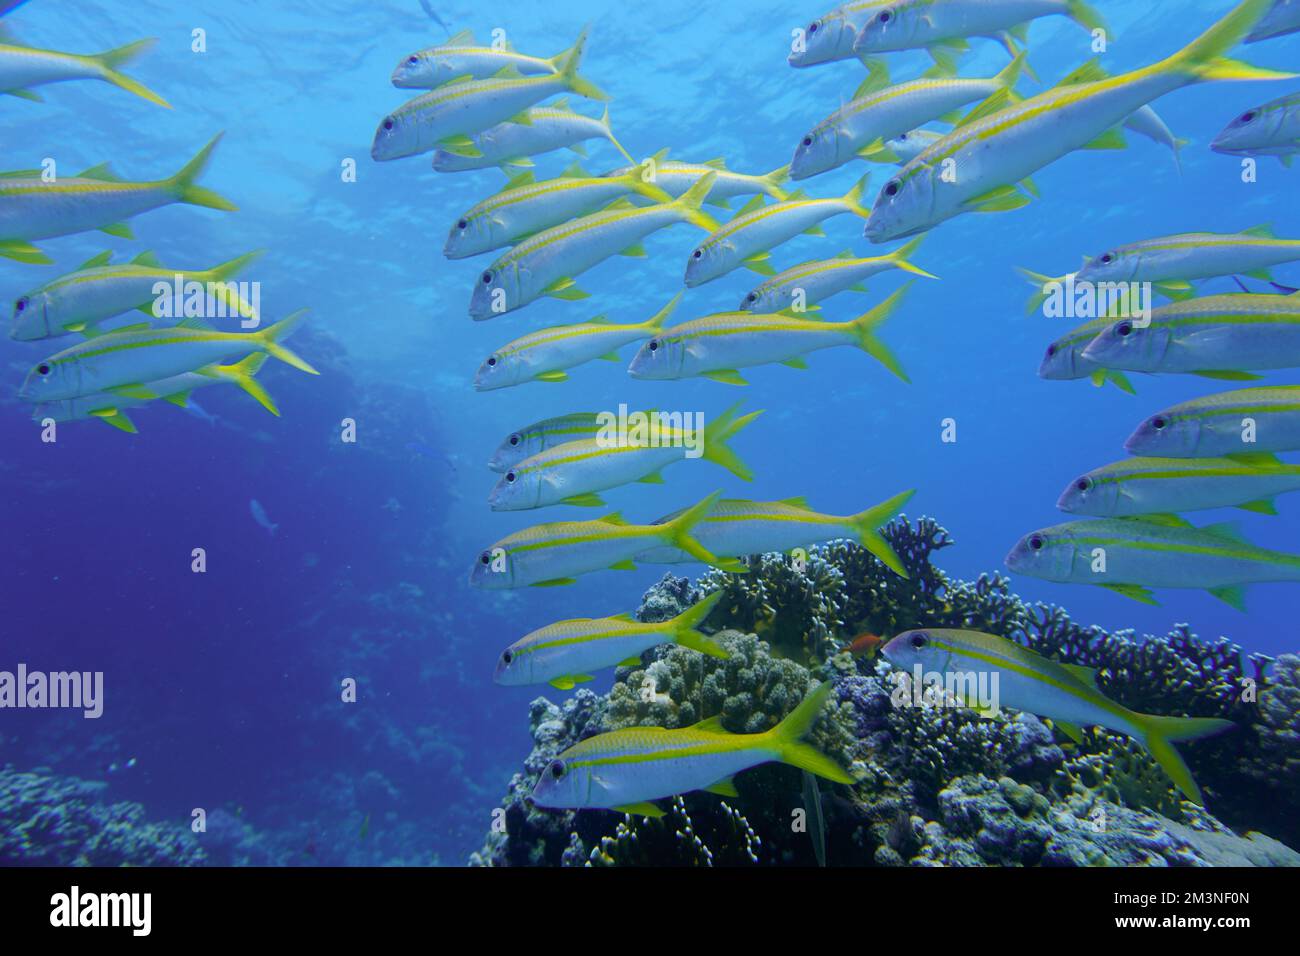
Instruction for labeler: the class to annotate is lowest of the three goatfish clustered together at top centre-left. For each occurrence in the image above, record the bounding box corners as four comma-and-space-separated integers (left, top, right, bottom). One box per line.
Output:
433, 100, 632, 173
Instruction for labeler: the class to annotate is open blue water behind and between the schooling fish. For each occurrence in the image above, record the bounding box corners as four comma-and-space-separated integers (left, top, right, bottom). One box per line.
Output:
0, 0, 1300, 864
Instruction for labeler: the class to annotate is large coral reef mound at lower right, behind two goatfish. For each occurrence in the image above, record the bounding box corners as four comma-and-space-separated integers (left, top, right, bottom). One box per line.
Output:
472, 518, 1300, 866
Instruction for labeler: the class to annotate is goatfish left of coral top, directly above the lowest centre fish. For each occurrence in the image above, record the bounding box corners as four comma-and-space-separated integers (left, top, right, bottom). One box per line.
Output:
493, 591, 731, 691
